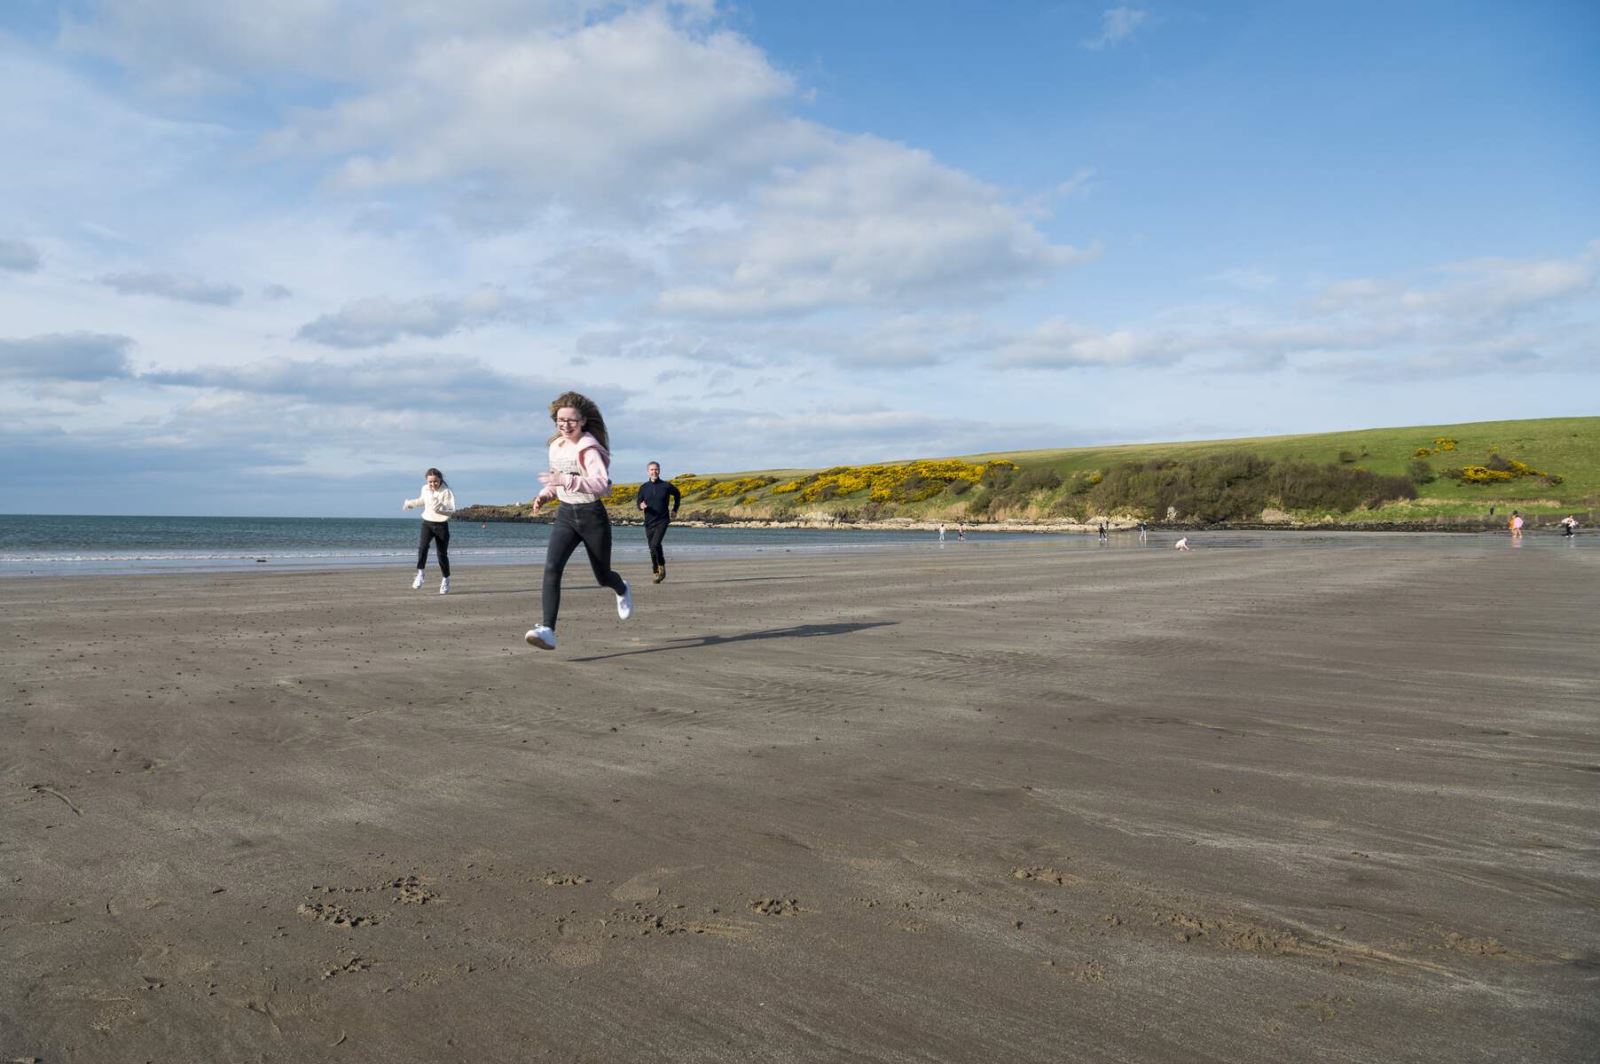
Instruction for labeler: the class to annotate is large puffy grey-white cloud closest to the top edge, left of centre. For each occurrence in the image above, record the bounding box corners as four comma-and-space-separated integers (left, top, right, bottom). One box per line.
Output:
272, 10, 806, 210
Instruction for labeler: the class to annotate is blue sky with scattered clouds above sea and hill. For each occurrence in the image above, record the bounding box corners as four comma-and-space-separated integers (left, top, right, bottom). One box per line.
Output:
0, 0, 1600, 517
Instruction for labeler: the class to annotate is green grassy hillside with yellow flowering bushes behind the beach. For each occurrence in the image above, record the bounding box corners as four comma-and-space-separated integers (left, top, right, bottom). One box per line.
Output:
457, 418, 1600, 525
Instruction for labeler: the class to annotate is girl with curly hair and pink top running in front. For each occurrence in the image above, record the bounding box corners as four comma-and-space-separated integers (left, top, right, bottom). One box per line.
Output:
523, 392, 634, 650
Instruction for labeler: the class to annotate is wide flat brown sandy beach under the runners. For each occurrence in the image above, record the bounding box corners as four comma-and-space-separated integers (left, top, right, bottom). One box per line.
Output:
0, 541, 1600, 1064
